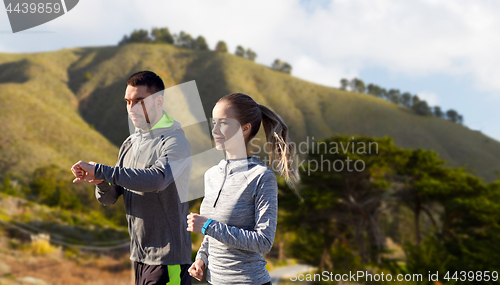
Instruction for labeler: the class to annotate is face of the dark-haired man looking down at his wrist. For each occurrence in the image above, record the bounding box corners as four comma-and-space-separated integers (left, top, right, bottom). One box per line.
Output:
125, 85, 162, 130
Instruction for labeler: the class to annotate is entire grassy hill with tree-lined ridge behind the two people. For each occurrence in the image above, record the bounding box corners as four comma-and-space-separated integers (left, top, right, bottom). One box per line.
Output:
0, 44, 500, 180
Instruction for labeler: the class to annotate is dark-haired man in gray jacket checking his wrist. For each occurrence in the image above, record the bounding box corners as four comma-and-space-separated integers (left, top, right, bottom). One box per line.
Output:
71, 71, 192, 285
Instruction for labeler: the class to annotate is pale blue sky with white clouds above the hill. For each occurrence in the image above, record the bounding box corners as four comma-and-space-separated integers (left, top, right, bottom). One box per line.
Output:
0, 0, 500, 140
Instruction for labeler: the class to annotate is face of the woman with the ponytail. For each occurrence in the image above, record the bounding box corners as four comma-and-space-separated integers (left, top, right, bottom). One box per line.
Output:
212, 102, 246, 152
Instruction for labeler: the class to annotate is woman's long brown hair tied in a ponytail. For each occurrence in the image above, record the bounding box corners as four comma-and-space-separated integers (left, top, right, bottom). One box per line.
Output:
217, 93, 300, 191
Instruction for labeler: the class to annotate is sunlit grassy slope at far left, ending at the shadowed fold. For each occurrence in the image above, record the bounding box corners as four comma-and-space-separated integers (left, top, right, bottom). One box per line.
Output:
0, 51, 117, 179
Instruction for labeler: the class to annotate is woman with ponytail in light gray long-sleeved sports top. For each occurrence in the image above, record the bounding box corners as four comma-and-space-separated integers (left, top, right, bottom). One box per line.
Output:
187, 93, 299, 285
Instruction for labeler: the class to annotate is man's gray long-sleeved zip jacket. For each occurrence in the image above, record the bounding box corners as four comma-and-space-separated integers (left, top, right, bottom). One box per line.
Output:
95, 118, 192, 265
